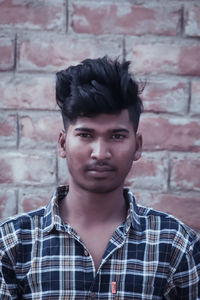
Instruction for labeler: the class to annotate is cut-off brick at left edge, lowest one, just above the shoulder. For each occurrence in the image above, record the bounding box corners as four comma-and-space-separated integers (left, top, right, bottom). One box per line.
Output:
0, 188, 17, 219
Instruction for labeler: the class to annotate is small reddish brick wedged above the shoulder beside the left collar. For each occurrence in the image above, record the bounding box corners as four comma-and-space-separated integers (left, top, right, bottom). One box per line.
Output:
18, 187, 54, 213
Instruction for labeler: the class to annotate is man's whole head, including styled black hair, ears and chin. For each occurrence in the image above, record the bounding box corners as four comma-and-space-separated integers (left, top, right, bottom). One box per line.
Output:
56, 57, 142, 194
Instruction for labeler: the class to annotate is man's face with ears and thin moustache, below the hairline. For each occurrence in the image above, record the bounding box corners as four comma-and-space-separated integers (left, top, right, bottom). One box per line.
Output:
59, 110, 142, 193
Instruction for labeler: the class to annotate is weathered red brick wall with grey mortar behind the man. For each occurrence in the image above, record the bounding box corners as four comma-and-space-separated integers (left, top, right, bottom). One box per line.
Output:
0, 0, 200, 231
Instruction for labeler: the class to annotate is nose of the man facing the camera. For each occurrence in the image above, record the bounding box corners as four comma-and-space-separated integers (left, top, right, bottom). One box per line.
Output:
91, 139, 111, 160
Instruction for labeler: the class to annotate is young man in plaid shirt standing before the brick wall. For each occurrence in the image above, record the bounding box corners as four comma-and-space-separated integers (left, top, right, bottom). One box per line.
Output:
0, 57, 200, 300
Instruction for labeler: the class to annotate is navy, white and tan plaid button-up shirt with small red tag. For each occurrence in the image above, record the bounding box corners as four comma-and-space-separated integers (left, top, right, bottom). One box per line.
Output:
0, 187, 200, 300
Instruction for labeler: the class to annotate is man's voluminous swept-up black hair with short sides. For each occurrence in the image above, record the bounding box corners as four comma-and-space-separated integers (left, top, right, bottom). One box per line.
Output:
56, 56, 143, 132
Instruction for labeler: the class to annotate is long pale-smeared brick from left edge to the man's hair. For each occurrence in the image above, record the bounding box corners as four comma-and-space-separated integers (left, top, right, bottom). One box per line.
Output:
0, 74, 56, 110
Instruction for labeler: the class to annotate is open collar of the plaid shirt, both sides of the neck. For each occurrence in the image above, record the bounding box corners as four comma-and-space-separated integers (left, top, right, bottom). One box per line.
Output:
44, 186, 141, 234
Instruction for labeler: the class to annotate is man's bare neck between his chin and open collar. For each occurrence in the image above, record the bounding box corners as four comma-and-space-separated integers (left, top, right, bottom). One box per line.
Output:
60, 185, 126, 225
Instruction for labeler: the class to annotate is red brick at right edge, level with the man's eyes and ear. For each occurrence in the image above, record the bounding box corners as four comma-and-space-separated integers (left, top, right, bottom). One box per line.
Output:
139, 114, 200, 151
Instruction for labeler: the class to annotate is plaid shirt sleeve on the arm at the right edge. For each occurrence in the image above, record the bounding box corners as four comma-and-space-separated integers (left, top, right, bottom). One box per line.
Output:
166, 232, 200, 300
